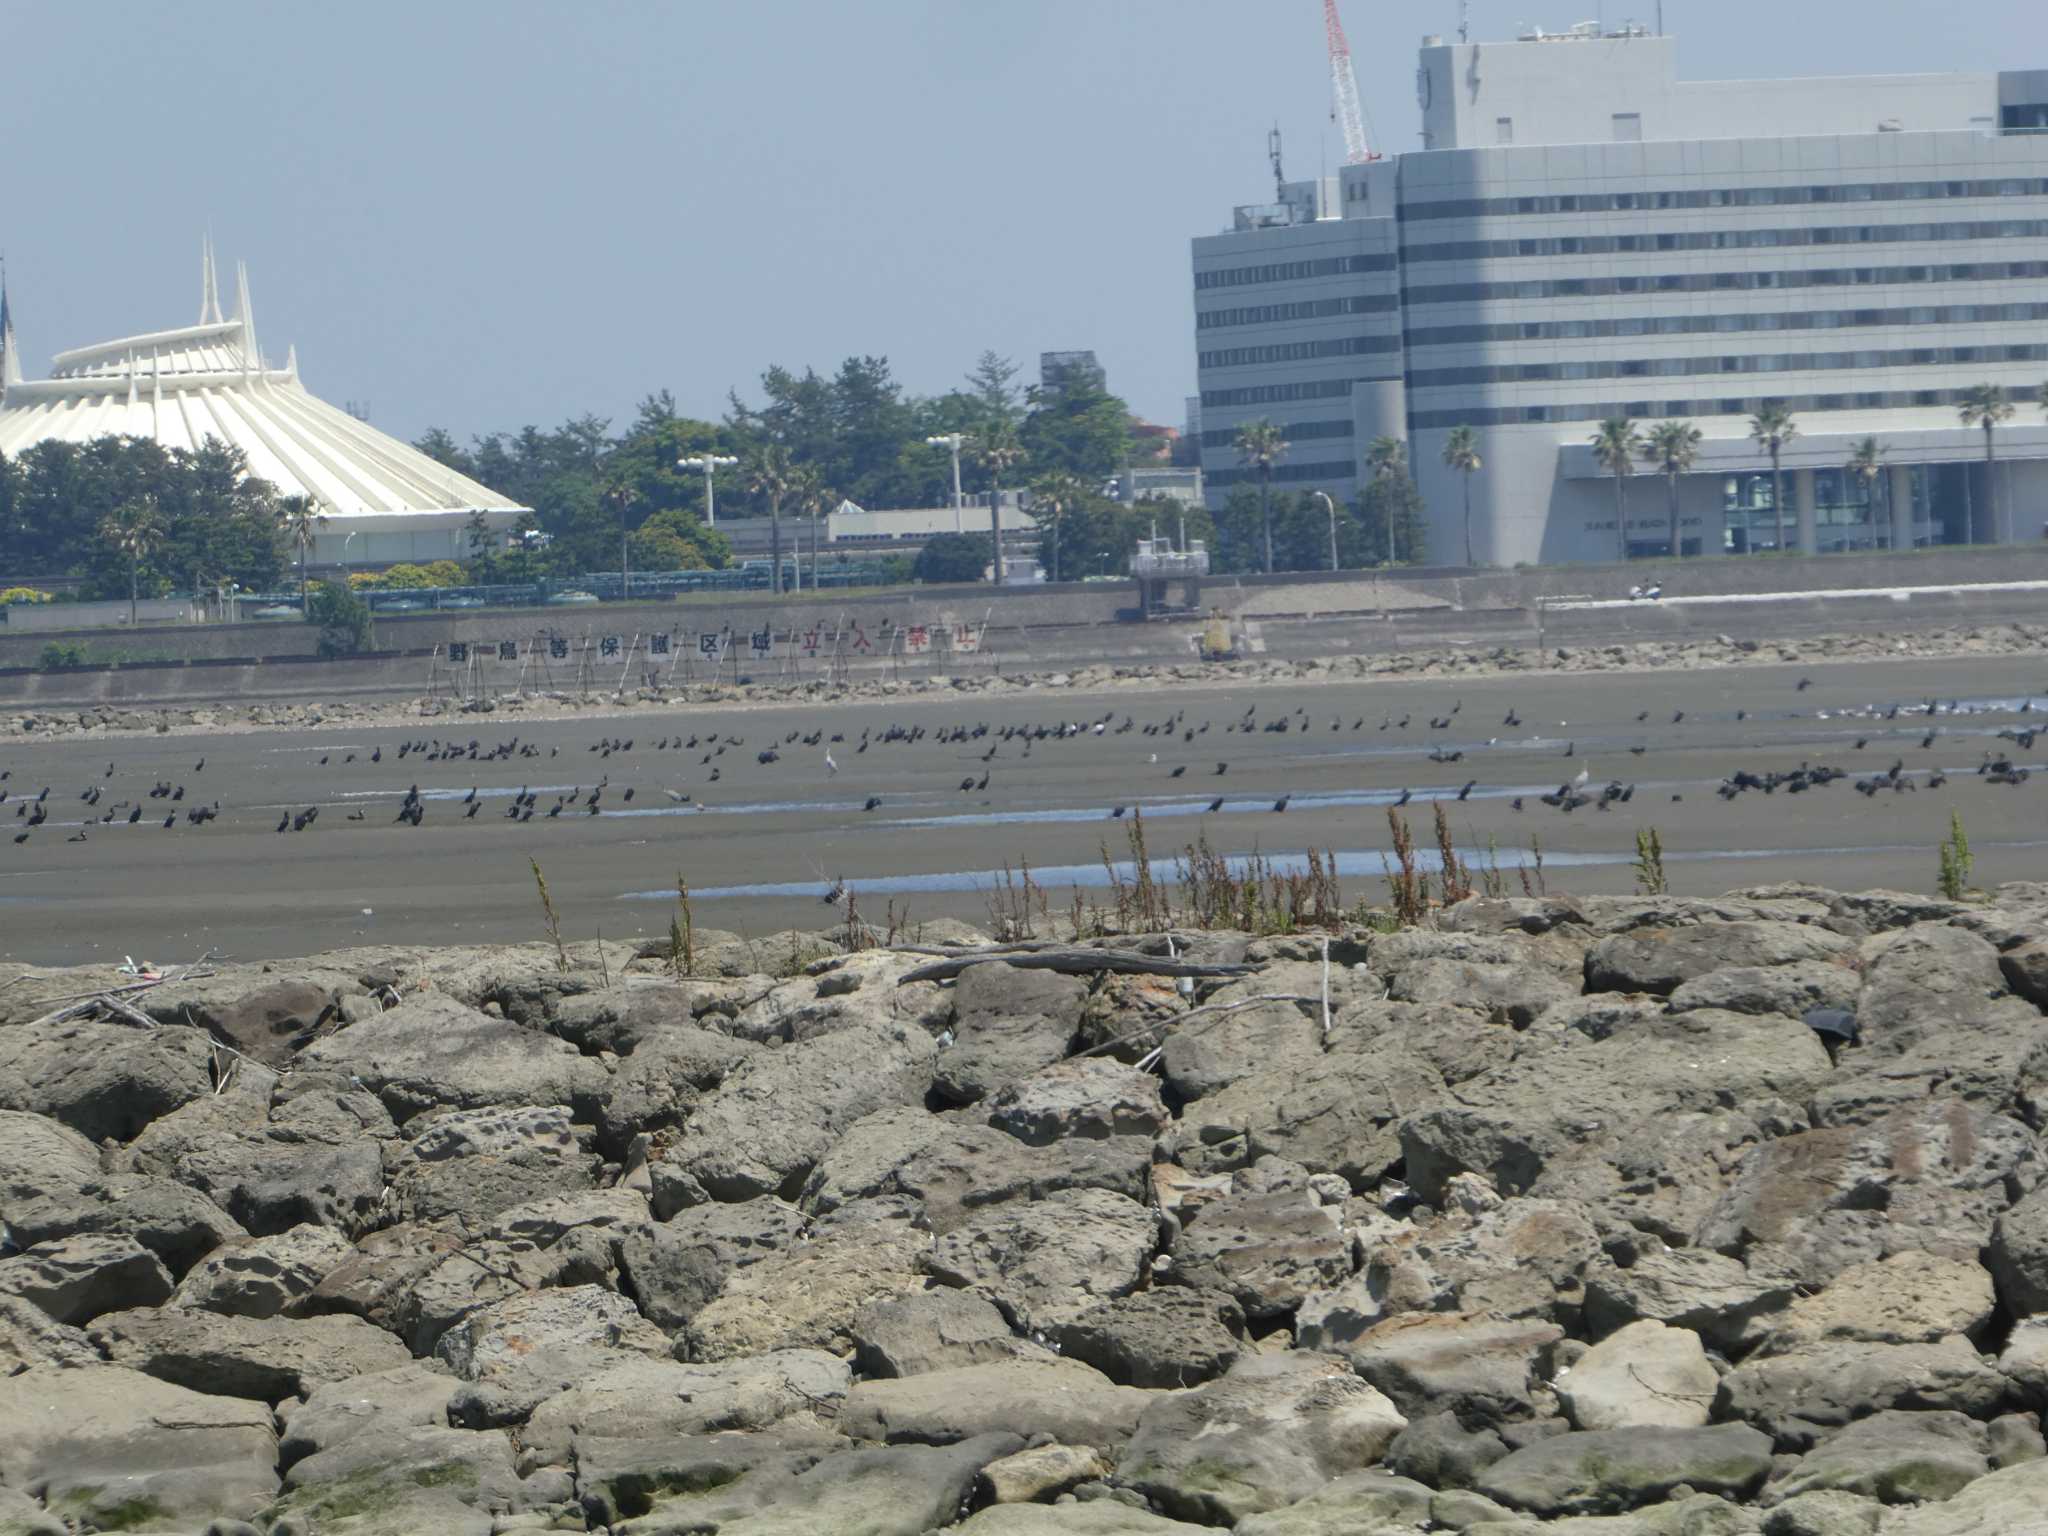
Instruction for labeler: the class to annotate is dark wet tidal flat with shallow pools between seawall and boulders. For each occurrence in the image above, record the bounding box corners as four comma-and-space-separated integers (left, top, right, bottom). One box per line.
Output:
0, 657, 2048, 965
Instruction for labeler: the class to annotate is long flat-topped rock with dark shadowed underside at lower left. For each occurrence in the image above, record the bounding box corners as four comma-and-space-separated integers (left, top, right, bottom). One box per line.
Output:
88, 1309, 412, 1403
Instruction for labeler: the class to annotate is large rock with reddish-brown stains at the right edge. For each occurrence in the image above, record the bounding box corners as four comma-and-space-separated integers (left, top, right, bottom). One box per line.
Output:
1698, 1098, 2040, 1284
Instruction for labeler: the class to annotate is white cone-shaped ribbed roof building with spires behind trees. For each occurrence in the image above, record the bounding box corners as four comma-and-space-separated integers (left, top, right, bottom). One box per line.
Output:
0, 242, 524, 563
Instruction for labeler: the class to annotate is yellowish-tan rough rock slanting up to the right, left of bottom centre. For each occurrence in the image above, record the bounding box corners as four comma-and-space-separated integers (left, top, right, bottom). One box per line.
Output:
678, 1204, 932, 1360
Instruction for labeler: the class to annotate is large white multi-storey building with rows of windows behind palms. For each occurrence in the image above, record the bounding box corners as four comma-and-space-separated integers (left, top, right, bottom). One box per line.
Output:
1194, 27, 2048, 565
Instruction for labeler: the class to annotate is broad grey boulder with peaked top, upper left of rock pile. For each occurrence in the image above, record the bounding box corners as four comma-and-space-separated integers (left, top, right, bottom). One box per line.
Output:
301, 993, 608, 1124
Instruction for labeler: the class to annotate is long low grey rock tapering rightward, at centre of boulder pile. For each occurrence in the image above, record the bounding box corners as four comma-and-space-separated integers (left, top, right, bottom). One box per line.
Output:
803, 1105, 1151, 1233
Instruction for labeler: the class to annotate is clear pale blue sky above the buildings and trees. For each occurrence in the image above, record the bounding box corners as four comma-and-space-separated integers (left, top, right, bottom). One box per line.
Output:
0, 0, 2048, 440
